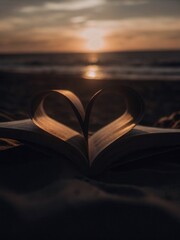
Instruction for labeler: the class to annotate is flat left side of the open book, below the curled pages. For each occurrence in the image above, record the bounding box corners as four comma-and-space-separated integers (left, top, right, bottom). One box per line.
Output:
0, 119, 88, 169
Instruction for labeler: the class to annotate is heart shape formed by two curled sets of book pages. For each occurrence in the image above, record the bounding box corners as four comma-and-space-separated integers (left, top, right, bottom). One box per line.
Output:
30, 86, 144, 163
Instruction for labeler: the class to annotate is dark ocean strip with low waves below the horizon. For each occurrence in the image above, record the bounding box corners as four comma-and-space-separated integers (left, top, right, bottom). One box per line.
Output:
0, 50, 180, 81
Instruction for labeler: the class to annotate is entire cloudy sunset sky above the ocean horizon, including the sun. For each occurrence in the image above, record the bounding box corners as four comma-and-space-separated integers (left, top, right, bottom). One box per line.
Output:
0, 0, 180, 53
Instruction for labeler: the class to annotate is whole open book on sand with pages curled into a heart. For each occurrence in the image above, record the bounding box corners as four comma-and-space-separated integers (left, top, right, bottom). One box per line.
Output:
0, 87, 180, 174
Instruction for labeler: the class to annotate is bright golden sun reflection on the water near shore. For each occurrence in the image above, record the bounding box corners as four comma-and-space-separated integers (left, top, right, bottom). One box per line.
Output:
83, 65, 103, 80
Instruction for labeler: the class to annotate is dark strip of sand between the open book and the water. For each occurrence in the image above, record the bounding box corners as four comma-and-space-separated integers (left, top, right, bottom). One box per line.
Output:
0, 72, 180, 126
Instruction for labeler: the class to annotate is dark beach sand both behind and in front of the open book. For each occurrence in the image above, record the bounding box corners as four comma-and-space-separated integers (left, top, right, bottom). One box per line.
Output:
0, 72, 180, 240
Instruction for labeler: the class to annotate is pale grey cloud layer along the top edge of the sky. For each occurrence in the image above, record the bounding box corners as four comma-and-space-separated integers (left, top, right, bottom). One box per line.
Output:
0, 0, 180, 20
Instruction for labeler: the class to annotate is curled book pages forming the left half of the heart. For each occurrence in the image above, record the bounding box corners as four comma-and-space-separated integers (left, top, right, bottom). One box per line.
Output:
31, 90, 87, 152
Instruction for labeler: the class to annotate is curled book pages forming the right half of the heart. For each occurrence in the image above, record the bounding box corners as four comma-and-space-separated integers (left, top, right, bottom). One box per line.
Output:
88, 86, 144, 164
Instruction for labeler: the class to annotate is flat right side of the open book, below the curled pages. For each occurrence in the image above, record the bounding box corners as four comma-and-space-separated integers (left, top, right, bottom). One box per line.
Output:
92, 125, 180, 174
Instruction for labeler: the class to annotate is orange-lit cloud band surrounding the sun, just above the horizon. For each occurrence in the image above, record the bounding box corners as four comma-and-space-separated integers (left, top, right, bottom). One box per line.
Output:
0, 17, 180, 52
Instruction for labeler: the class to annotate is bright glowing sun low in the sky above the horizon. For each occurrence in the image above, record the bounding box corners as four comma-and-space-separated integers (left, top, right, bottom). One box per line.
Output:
81, 28, 104, 52
